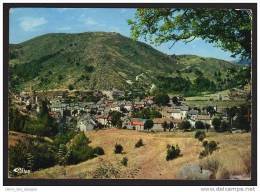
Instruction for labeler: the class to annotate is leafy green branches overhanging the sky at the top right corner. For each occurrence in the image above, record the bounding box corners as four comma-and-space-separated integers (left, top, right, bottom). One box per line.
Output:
128, 8, 252, 58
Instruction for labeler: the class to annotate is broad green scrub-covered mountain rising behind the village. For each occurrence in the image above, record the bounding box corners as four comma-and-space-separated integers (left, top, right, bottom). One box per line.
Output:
9, 32, 238, 93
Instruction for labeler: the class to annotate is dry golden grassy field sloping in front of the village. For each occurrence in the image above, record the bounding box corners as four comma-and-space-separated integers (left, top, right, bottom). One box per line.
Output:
22, 129, 251, 179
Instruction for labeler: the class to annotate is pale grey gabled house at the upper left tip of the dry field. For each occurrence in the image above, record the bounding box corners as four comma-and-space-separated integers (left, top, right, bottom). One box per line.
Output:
76, 113, 97, 131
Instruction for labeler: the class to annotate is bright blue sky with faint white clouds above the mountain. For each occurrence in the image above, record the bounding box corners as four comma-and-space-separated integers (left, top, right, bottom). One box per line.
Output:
9, 8, 235, 61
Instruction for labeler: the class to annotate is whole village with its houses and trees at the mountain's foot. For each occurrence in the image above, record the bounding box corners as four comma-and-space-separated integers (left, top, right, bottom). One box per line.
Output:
11, 86, 249, 132
